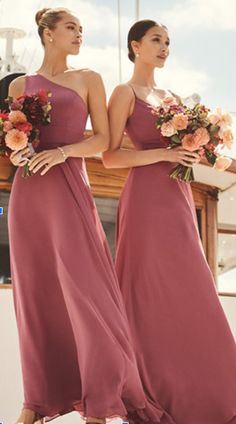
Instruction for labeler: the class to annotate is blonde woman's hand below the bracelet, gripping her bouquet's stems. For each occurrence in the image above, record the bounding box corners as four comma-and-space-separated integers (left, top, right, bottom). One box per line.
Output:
29, 149, 65, 175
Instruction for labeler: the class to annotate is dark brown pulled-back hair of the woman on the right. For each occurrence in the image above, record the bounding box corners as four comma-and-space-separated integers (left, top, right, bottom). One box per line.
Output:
127, 19, 167, 62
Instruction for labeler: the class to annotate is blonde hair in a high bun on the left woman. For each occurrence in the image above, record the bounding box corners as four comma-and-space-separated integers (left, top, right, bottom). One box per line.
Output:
35, 7, 71, 45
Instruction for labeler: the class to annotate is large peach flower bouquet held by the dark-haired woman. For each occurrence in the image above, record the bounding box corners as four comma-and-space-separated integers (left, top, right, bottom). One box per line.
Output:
153, 96, 233, 182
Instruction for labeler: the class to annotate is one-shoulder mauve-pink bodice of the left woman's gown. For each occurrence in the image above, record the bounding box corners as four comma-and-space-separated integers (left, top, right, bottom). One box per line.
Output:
25, 74, 88, 151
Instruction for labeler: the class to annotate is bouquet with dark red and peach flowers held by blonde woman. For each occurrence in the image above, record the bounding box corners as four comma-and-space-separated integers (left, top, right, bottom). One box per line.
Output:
0, 90, 51, 177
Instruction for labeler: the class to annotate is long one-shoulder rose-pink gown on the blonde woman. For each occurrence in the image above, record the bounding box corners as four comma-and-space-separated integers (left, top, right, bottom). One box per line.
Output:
9, 74, 175, 424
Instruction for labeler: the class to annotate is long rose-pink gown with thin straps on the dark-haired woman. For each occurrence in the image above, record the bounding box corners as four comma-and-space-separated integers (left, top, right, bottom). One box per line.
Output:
116, 87, 236, 424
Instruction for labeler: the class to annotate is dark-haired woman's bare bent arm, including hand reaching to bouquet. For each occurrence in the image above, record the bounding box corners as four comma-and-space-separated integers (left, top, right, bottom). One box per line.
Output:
103, 84, 199, 168
